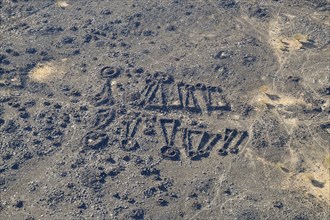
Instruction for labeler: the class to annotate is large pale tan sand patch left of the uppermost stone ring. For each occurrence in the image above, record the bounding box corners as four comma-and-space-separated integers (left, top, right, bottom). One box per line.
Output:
29, 60, 66, 82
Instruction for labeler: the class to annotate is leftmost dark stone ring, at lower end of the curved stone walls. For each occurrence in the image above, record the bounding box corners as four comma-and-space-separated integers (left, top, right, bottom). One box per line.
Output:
83, 131, 109, 150
